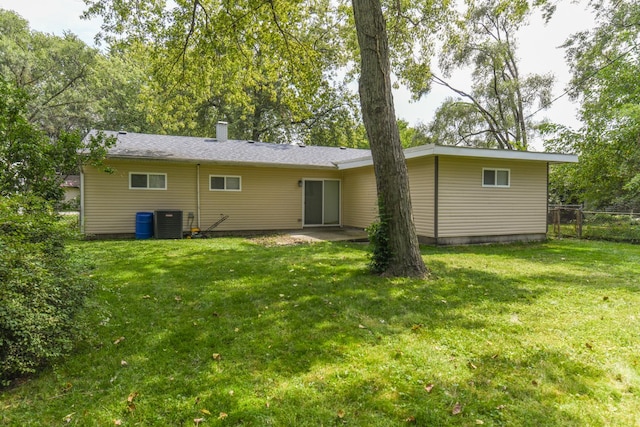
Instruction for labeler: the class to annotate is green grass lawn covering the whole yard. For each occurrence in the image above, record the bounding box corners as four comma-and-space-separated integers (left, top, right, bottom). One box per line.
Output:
0, 238, 640, 426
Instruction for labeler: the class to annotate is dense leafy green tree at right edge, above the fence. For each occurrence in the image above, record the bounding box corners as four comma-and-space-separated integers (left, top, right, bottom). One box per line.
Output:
546, 1, 640, 211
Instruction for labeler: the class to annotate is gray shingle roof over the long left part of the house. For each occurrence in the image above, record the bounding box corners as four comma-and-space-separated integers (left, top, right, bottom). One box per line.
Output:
90, 131, 371, 168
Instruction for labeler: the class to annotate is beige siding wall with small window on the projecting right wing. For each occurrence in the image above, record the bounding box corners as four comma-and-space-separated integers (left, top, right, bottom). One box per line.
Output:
438, 156, 547, 237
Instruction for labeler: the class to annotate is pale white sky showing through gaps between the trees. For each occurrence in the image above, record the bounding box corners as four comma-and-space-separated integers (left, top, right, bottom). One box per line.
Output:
0, 0, 593, 148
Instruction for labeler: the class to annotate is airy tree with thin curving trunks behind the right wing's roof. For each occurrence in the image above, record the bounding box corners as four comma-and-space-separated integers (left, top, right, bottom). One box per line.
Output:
430, 0, 554, 150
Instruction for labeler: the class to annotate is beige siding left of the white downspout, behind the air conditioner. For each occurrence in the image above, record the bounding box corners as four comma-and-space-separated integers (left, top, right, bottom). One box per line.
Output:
83, 160, 196, 234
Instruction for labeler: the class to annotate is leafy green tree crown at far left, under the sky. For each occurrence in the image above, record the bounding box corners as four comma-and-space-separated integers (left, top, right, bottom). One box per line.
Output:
0, 10, 98, 136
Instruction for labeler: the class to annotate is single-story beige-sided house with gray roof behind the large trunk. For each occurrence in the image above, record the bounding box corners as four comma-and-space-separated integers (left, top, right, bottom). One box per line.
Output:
81, 123, 577, 244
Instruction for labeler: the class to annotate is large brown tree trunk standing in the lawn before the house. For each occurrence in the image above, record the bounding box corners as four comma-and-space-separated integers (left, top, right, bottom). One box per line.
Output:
352, 0, 427, 277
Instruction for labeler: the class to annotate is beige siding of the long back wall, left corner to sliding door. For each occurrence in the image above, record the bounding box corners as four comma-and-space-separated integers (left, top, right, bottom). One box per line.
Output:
84, 160, 340, 234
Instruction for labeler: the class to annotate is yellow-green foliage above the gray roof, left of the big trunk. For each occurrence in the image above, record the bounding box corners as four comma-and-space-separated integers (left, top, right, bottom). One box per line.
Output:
87, 0, 362, 146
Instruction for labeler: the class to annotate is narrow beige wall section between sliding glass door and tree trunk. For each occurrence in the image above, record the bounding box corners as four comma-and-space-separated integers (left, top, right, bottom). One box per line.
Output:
342, 166, 378, 228
